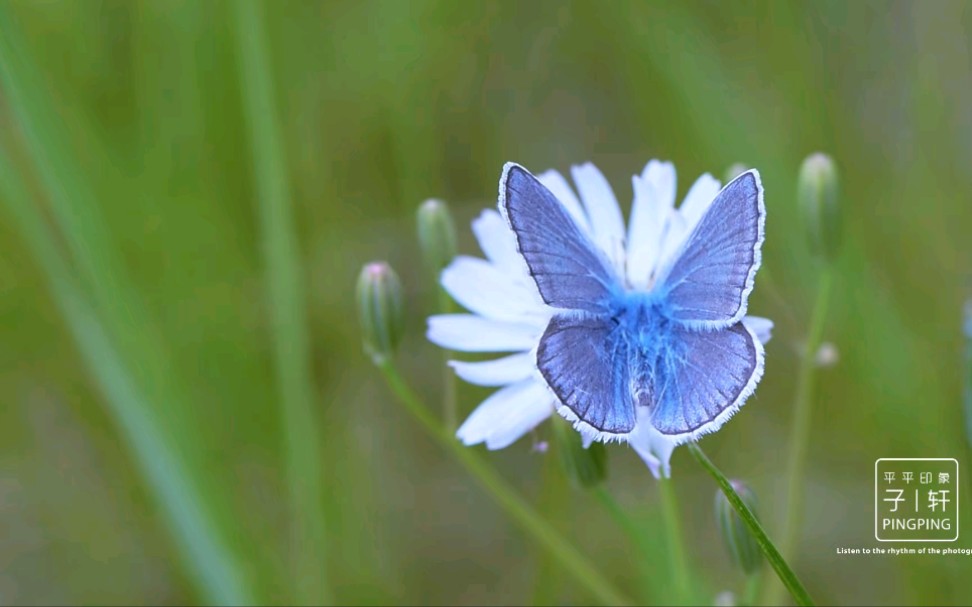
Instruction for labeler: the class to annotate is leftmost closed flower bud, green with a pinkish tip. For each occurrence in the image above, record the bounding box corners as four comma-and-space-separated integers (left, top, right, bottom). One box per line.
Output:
357, 261, 405, 364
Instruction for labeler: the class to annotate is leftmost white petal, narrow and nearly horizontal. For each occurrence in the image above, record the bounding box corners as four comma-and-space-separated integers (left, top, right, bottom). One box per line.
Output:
426, 314, 540, 352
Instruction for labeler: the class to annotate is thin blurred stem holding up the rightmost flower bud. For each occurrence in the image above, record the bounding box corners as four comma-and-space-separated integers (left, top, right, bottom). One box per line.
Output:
766, 265, 833, 604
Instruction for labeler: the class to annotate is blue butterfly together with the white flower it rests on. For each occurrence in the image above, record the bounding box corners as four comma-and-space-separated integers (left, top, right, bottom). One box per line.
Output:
429, 161, 772, 476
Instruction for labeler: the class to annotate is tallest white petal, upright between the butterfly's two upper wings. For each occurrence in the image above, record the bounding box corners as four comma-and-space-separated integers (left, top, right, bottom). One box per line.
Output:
626, 160, 675, 288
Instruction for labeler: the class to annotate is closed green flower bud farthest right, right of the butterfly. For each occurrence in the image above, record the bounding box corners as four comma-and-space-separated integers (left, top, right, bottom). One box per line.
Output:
797, 152, 840, 262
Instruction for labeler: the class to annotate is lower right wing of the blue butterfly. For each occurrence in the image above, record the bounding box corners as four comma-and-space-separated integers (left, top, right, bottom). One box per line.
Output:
651, 323, 763, 436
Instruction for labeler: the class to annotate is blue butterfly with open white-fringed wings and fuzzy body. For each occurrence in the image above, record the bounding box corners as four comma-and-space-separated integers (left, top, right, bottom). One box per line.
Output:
499, 163, 766, 442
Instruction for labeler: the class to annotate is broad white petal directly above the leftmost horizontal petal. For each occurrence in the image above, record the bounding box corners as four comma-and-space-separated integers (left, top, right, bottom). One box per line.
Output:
441, 255, 549, 329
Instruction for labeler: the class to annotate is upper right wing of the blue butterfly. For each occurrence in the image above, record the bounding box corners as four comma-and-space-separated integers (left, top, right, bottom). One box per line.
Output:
656, 170, 766, 329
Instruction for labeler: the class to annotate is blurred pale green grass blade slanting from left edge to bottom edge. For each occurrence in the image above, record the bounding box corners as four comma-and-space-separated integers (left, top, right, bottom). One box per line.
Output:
0, 145, 254, 605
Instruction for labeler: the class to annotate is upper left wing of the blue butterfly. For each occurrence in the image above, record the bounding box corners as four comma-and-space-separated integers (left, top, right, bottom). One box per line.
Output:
500, 163, 621, 313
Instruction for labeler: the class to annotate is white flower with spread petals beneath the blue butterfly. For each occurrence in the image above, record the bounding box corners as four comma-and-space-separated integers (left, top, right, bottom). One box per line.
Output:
428, 160, 773, 477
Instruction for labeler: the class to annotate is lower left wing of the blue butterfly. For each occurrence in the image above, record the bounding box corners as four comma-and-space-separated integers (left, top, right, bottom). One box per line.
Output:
537, 315, 647, 434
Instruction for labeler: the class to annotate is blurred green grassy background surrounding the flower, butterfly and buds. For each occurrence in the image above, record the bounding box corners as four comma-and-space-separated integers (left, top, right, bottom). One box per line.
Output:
0, 0, 972, 604
